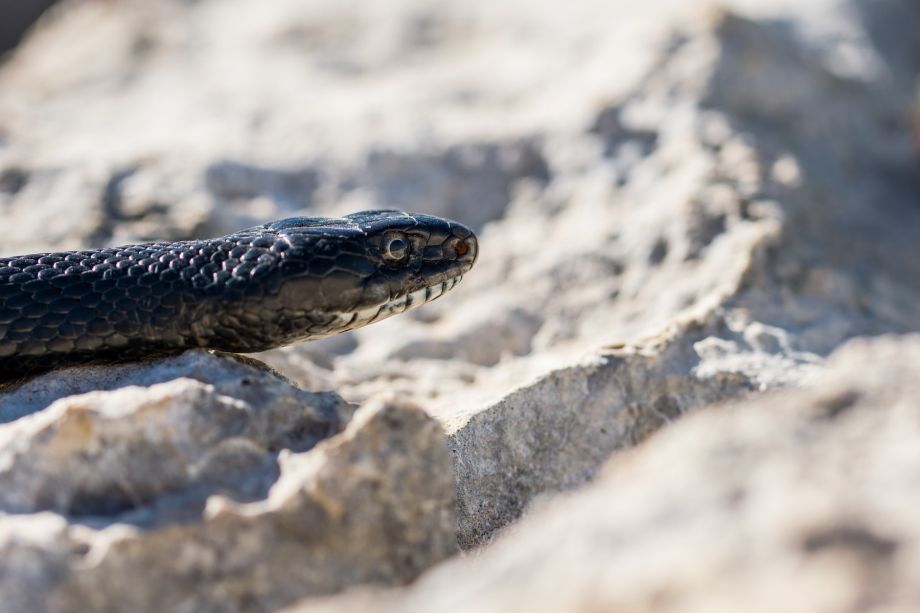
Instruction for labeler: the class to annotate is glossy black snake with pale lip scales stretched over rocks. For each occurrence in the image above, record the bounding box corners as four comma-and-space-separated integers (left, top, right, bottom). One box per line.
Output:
0, 210, 478, 379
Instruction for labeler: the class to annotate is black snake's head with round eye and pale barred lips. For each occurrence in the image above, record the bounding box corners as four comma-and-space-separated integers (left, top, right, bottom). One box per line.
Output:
263, 210, 478, 340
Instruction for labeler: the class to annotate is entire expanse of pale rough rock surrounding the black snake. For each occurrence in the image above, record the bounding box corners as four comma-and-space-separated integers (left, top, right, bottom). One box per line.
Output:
0, 0, 920, 611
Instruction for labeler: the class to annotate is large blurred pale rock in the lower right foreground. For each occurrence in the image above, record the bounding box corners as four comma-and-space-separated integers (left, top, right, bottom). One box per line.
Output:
287, 336, 920, 613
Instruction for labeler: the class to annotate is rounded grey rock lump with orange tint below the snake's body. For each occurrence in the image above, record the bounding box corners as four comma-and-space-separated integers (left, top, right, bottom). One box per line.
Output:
0, 379, 351, 520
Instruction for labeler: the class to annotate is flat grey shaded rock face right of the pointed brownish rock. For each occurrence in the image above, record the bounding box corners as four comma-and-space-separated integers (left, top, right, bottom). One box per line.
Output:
450, 331, 757, 548
